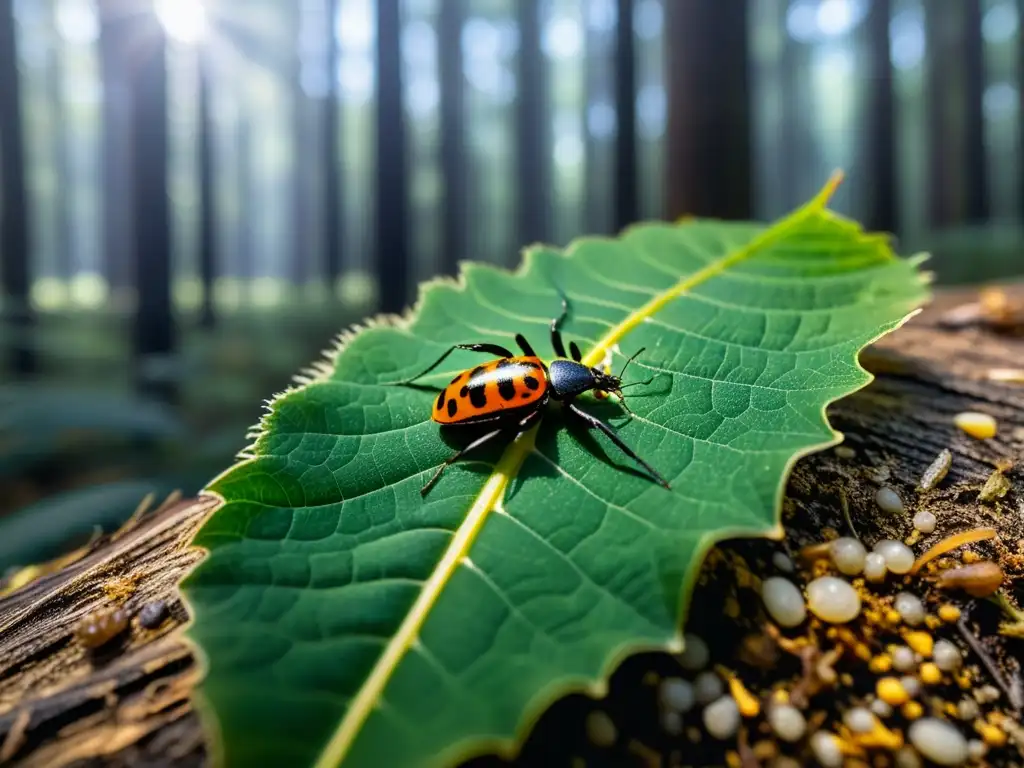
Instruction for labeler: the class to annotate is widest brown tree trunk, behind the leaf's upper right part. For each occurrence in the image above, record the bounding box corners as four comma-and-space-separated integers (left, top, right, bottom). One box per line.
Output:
663, 0, 752, 219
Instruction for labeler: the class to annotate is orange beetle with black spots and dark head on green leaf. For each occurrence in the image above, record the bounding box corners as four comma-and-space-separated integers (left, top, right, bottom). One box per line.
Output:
389, 295, 669, 496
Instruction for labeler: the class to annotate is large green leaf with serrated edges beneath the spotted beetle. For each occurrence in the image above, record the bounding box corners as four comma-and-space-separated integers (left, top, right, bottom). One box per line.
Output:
186, 178, 927, 768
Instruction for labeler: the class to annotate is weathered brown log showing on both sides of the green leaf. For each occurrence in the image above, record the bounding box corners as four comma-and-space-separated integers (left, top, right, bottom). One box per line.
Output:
0, 287, 1024, 767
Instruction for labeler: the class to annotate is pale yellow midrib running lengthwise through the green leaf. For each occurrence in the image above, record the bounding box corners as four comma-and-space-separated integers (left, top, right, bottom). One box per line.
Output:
316, 171, 843, 768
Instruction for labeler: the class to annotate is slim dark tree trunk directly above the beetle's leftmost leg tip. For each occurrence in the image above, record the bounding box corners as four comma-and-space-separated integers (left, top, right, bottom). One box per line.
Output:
376, 0, 410, 312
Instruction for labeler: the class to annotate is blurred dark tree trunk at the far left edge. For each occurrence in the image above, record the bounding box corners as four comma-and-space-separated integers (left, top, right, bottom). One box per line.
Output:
0, 0, 36, 378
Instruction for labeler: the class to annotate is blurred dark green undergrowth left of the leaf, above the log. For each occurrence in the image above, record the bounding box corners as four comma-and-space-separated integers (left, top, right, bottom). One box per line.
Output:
0, 303, 367, 571
